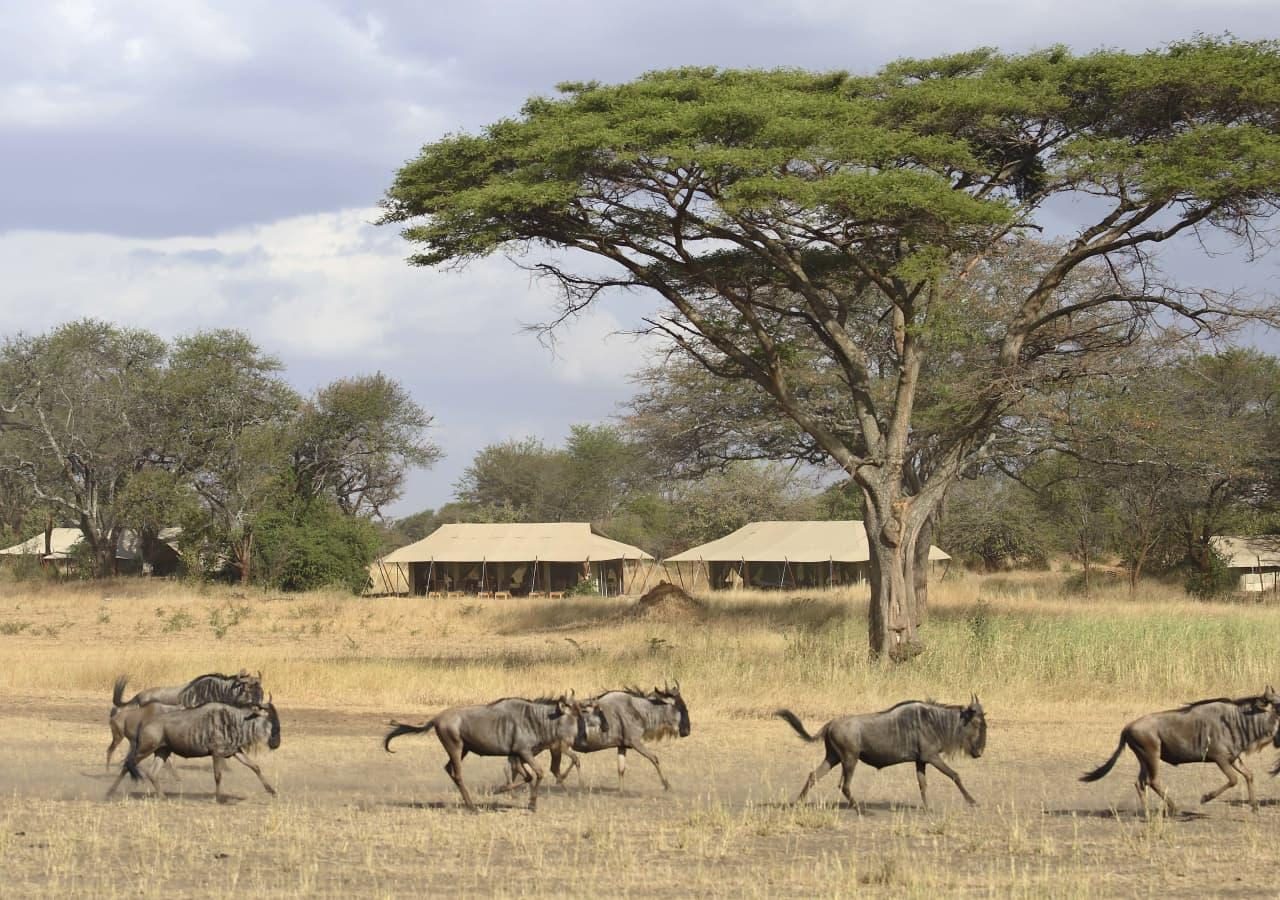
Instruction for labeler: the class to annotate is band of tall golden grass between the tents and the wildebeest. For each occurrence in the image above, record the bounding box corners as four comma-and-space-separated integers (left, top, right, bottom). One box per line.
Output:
0, 574, 1280, 716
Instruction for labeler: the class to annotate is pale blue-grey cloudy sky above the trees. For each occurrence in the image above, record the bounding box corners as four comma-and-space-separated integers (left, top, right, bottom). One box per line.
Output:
0, 0, 1280, 515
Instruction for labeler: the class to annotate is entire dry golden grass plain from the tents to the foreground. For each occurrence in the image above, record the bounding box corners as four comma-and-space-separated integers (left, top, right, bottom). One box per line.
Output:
0, 572, 1280, 897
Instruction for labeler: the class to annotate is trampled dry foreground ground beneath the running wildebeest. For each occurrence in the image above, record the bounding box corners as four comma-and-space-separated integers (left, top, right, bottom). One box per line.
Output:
0, 695, 1280, 896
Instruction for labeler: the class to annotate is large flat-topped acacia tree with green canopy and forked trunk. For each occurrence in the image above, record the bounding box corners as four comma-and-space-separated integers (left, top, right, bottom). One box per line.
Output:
383, 38, 1280, 658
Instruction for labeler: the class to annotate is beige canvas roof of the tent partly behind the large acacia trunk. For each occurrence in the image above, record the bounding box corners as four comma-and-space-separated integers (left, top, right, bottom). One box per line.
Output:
667, 518, 951, 562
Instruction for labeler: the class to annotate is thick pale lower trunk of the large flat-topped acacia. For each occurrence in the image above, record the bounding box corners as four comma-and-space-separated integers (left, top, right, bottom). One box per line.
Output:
863, 486, 923, 662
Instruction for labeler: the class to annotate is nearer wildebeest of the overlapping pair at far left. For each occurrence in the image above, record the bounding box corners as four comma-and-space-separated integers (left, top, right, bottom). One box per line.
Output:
106, 699, 280, 803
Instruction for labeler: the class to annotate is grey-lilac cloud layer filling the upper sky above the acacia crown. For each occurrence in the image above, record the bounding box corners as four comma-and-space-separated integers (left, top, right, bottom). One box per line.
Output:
10, 0, 1280, 236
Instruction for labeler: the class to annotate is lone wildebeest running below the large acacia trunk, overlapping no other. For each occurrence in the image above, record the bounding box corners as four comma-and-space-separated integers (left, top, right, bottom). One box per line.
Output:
774, 696, 987, 809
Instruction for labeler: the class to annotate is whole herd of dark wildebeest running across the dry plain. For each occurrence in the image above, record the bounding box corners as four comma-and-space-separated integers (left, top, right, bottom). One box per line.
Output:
106, 671, 1280, 813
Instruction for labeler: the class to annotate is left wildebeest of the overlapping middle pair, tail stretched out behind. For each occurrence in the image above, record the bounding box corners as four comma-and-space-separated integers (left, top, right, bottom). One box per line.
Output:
383, 696, 594, 810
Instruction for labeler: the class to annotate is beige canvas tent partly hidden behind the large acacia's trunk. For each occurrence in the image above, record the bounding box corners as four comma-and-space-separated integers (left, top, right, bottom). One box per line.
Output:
664, 520, 951, 590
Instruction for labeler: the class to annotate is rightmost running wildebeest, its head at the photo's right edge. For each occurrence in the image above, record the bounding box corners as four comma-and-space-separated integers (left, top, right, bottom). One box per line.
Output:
1080, 685, 1280, 813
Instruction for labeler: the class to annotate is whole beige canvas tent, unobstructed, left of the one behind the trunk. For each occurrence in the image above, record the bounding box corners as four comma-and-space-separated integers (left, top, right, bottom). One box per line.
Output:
375, 522, 653, 597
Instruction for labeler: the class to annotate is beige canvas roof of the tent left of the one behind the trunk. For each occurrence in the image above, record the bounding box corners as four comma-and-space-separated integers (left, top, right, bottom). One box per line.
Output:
383, 522, 653, 562
